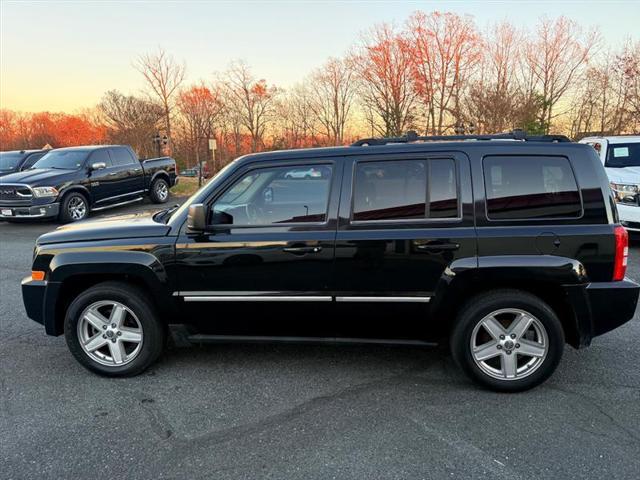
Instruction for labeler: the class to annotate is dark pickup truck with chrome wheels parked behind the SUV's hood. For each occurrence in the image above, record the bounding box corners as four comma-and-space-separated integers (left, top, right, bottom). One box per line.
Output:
0, 145, 178, 223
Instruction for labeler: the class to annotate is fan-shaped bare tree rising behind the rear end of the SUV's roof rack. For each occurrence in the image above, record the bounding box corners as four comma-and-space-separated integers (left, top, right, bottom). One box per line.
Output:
524, 17, 599, 131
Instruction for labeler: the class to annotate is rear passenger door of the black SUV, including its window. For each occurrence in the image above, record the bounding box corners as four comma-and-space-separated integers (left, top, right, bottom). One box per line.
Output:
335, 152, 476, 338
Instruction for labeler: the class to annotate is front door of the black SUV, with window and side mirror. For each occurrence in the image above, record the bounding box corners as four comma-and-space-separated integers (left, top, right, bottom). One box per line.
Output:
176, 158, 342, 335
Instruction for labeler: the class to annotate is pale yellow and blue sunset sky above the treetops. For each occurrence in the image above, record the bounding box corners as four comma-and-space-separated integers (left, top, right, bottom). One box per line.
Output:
0, 0, 640, 112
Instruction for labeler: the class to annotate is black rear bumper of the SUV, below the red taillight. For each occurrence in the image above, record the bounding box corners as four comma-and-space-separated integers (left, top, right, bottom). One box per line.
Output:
565, 280, 640, 348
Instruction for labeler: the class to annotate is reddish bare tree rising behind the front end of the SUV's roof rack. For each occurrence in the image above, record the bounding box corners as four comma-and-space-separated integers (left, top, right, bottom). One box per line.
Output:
349, 24, 416, 136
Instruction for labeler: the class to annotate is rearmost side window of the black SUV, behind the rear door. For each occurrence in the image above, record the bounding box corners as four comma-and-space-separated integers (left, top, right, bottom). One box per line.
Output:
484, 156, 582, 220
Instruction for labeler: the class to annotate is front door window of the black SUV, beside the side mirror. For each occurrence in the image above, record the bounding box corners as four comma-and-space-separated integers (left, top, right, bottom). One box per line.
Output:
212, 165, 333, 226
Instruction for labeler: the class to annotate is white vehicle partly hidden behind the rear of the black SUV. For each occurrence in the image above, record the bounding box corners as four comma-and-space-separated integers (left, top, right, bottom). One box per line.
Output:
580, 135, 640, 232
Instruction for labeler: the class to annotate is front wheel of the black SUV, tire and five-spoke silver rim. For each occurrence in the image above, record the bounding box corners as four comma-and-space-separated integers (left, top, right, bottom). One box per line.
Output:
64, 282, 166, 377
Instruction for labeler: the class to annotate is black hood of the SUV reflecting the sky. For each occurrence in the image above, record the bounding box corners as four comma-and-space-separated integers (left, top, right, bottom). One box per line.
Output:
37, 213, 170, 245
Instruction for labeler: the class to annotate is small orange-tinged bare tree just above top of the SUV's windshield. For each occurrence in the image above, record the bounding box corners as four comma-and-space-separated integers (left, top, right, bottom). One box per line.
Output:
223, 62, 277, 152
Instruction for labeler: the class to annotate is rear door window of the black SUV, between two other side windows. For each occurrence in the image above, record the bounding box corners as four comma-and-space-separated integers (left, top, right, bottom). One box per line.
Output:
352, 159, 458, 221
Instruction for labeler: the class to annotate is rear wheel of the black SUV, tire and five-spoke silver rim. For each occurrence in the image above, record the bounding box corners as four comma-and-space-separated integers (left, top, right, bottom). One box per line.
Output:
450, 290, 565, 392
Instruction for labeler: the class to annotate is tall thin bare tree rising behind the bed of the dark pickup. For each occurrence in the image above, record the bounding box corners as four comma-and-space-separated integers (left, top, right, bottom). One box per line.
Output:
134, 48, 186, 151
